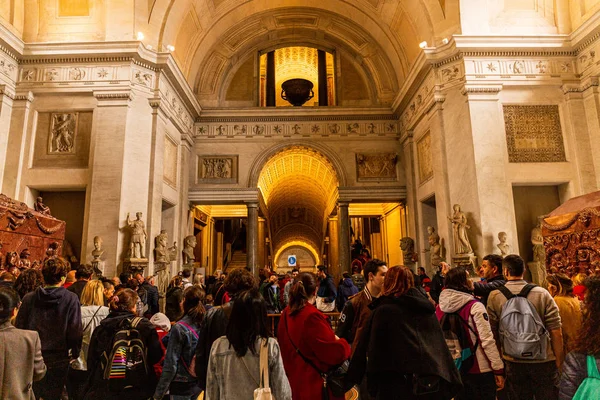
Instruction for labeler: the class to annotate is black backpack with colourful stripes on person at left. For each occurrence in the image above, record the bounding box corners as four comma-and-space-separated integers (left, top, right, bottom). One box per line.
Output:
101, 317, 149, 392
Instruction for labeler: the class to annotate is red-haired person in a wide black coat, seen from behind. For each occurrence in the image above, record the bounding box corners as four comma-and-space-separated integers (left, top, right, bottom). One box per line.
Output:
347, 266, 461, 400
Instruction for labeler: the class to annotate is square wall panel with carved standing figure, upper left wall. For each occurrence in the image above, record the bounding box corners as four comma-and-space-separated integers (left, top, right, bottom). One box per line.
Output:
32, 111, 92, 168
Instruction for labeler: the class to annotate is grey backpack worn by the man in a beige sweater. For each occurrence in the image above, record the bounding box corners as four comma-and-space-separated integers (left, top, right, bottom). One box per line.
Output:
499, 284, 550, 360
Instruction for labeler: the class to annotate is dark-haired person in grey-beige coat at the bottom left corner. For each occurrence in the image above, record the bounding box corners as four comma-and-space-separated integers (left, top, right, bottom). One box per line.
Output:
0, 287, 46, 400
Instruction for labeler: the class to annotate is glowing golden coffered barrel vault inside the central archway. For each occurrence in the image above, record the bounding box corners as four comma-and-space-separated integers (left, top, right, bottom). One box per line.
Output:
258, 146, 339, 260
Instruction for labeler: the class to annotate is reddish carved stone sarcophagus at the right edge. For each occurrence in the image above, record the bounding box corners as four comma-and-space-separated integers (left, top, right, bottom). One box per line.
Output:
542, 191, 600, 275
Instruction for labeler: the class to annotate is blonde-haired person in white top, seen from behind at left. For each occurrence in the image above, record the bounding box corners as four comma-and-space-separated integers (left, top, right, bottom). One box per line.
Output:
67, 280, 109, 400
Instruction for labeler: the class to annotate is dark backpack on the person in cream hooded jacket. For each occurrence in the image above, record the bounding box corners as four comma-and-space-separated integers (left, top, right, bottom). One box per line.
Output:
440, 301, 479, 374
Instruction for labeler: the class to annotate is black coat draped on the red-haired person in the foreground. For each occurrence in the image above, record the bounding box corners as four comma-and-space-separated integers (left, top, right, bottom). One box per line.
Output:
348, 288, 462, 400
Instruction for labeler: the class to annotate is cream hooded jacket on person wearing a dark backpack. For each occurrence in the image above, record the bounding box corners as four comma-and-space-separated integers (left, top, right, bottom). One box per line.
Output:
436, 289, 504, 375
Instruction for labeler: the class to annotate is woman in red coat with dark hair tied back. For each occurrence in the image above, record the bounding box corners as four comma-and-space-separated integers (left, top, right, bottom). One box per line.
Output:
277, 272, 350, 400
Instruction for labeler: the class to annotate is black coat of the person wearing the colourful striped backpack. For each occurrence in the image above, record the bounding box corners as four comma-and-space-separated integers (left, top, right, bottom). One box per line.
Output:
85, 311, 162, 400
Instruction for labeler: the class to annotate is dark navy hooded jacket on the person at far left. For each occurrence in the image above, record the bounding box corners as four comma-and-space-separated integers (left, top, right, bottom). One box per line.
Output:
15, 287, 83, 364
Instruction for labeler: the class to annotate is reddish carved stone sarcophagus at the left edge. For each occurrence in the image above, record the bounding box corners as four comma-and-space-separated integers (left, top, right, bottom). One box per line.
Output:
0, 194, 66, 269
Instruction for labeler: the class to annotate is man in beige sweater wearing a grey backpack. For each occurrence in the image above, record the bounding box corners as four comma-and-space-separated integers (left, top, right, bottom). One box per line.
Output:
487, 254, 564, 400
